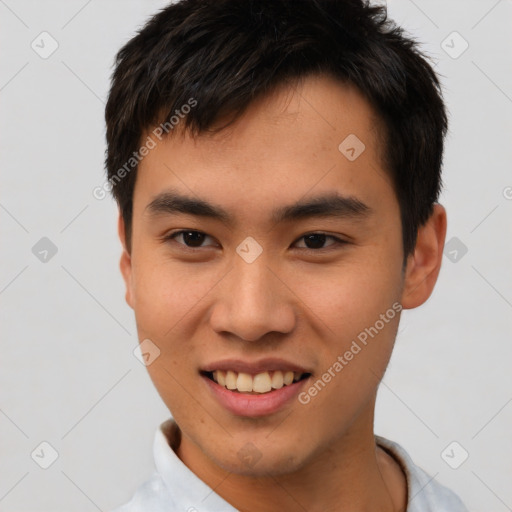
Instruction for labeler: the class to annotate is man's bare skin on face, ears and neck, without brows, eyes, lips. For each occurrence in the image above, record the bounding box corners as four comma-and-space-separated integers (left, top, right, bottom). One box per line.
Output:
118, 76, 446, 512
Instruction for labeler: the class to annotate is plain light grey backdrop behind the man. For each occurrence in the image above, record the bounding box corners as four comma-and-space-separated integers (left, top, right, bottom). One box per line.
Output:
0, 0, 512, 512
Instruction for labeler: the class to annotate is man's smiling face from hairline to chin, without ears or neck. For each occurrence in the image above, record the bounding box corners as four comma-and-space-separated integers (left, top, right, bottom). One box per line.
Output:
120, 76, 416, 475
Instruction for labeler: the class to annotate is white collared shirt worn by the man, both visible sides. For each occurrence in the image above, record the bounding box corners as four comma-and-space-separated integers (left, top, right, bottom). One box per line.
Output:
112, 418, 468, 512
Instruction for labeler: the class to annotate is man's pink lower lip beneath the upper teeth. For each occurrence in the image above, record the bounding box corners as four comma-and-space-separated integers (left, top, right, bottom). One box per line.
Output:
201, 375, 309, 418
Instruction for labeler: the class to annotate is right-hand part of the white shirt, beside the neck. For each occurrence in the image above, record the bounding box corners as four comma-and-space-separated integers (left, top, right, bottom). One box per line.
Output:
375, 436, 468, 512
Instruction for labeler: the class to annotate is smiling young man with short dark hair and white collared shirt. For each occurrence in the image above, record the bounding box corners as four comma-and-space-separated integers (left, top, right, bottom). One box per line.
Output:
106, 0, 466, 512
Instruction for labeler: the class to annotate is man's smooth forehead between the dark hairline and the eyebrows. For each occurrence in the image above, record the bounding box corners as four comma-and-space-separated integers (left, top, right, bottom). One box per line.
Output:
134, 76, 393, 224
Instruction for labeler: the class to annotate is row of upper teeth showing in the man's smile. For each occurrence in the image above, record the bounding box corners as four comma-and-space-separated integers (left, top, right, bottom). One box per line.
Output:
213, 370, 303, 393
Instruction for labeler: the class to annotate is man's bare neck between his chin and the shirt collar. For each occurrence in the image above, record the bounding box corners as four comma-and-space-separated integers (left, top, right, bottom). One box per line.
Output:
177, 404, 407, 512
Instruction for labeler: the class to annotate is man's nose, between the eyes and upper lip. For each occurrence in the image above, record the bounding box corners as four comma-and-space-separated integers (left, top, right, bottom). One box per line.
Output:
210, 254, 296, 341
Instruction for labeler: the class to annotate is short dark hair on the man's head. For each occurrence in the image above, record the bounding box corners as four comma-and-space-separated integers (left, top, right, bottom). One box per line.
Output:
105, 0, 447, 262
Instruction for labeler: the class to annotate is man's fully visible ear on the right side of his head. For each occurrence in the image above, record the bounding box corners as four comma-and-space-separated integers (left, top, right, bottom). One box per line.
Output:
402, 204, 447, 309
